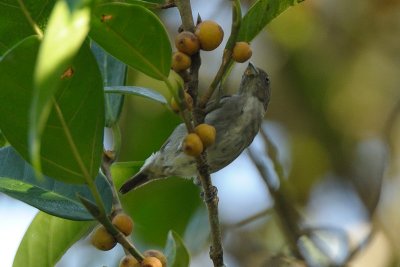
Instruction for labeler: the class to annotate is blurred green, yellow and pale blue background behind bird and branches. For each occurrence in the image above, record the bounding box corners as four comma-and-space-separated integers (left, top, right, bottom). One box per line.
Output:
0, 0, 400, 267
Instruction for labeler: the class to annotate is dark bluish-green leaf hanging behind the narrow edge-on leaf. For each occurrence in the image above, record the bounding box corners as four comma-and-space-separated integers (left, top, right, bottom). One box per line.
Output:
91, 42, 126, 127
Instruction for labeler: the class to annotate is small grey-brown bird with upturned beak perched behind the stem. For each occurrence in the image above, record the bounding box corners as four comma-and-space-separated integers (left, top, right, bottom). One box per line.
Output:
119, 63, 271, 194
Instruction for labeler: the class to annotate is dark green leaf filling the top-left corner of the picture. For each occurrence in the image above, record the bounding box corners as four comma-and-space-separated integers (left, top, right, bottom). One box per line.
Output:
0, 0, 55, 55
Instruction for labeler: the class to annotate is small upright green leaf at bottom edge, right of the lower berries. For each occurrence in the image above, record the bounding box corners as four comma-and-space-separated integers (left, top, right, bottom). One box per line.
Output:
165, 231, 190, 267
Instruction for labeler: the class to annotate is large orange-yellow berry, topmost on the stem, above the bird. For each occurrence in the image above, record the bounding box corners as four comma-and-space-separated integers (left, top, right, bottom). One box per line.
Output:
195, 20, 224, 51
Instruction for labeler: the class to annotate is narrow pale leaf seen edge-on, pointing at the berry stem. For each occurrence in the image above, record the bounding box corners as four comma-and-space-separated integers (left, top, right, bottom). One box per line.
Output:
104, 86, 168, 104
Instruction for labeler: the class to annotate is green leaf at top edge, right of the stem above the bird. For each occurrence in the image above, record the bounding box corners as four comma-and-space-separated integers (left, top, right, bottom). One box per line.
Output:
238, 0, 304, 42
